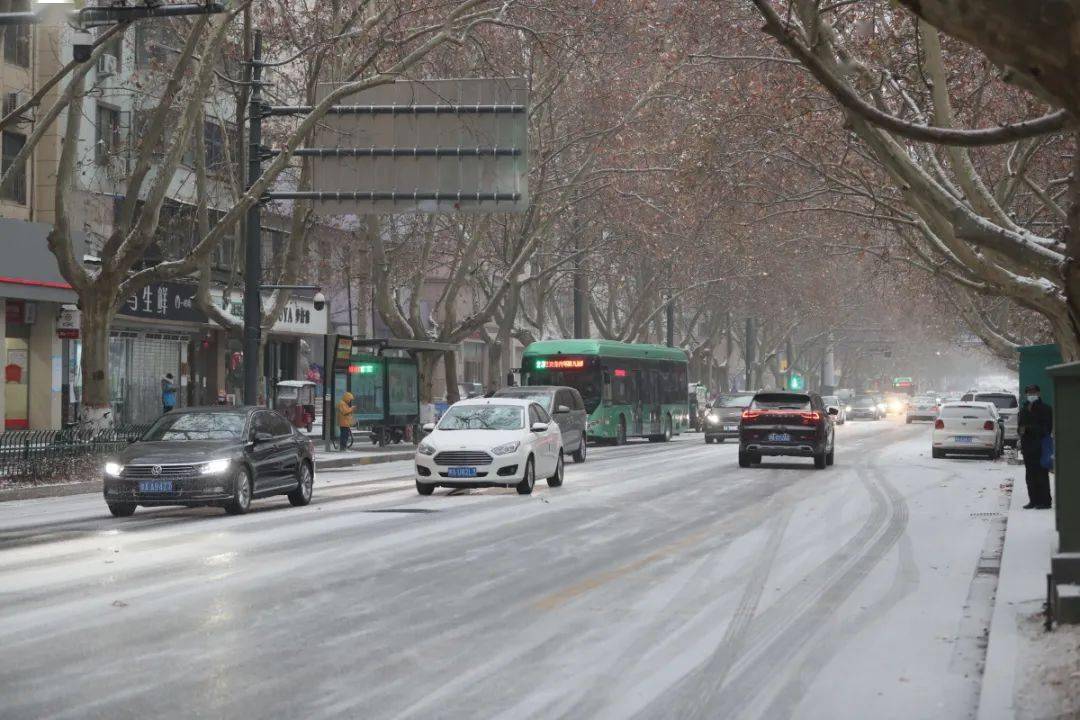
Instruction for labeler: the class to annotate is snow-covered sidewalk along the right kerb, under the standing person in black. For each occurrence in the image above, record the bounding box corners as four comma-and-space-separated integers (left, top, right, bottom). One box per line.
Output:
977, 479, 1067, 720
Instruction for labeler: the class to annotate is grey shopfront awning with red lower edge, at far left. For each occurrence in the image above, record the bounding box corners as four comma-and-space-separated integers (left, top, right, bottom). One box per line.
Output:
0, 218, 86, 303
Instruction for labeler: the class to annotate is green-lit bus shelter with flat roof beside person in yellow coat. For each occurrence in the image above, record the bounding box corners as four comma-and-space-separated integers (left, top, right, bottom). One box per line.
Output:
323, 335, 458, 449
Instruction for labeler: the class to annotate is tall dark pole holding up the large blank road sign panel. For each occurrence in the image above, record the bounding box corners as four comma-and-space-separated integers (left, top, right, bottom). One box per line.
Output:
244, 30, 262, 405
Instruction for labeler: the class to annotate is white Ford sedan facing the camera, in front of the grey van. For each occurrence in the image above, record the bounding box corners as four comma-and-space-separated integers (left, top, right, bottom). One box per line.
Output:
416, 397, 563, 495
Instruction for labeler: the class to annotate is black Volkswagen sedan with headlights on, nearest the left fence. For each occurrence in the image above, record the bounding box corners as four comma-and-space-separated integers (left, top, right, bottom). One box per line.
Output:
105, 407, 315, 517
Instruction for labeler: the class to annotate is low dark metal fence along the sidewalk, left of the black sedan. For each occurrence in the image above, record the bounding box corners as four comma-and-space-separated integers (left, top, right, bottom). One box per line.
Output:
0, 425, 149, 483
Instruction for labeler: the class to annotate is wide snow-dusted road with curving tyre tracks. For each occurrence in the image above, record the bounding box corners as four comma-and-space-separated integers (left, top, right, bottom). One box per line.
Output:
0, 421, 1018, 720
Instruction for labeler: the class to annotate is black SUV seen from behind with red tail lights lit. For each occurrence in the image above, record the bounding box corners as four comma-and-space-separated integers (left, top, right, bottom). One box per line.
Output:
739, 392, 837, 470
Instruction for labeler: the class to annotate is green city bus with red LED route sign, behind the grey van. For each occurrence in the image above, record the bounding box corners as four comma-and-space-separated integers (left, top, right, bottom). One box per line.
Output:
522, 340, 690, 445
